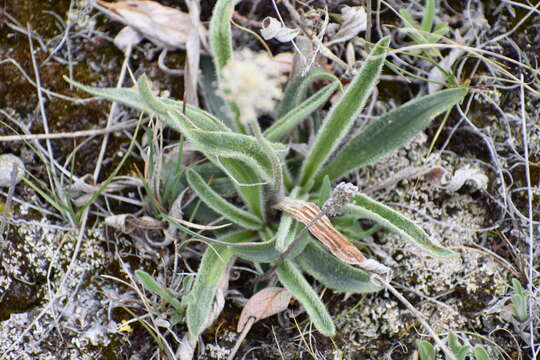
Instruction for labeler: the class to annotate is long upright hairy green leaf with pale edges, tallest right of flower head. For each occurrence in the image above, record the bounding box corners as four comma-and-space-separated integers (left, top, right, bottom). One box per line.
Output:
300, 37, 390, 186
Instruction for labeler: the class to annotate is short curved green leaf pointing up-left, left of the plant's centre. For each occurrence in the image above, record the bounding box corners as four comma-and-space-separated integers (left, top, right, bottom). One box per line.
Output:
187, 170, 263, 230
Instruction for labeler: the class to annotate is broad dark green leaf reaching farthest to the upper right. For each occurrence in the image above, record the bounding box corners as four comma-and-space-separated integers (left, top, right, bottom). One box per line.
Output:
315, 88, 467, 186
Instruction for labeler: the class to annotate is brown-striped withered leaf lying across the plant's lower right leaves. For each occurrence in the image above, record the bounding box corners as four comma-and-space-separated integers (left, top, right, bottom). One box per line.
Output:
276, 197, 389, 274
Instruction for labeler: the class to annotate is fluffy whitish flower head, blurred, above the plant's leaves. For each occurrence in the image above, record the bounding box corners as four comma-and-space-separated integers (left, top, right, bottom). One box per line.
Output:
222, 49, 284, 124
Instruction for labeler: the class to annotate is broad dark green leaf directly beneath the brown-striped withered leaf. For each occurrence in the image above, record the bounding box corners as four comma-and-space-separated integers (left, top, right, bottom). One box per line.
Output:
295, 241, 381, 293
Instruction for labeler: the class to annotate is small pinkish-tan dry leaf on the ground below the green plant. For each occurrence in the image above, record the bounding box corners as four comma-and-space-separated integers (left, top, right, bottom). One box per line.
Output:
236, 287, 292, 332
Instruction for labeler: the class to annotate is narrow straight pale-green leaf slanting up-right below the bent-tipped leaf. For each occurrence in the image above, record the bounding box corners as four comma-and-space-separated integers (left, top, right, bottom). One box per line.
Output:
264, 82, 339, 141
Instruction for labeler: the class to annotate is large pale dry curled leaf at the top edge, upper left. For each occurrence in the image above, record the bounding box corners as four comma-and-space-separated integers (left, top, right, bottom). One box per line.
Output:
97, 0, 192, 50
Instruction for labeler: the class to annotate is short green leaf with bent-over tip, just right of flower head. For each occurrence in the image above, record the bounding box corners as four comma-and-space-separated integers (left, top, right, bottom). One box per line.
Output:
276, 68, 341, 119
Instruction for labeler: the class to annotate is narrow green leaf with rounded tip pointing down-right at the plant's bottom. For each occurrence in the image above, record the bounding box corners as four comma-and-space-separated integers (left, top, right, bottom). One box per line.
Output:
276, 260, 336, 336
